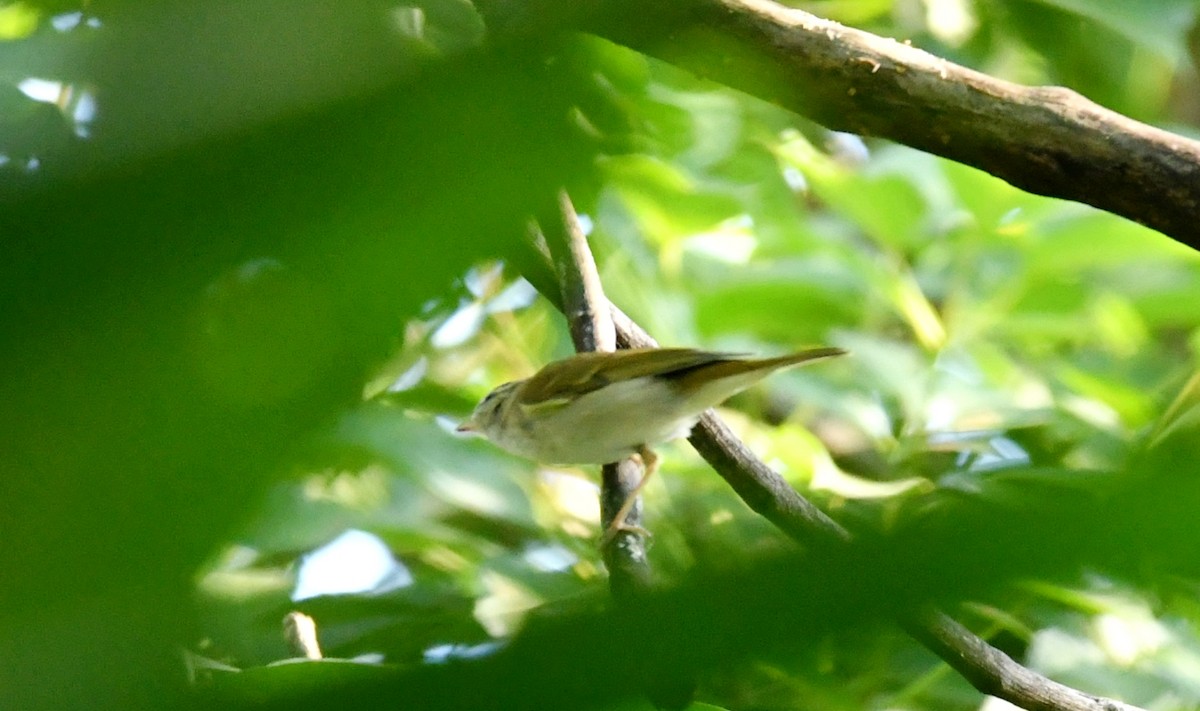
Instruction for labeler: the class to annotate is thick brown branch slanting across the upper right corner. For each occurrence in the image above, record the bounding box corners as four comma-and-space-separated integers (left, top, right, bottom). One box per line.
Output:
484, 0, 1200, 249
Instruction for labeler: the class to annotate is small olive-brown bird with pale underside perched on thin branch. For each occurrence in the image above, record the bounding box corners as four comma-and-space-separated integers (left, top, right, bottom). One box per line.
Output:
457, 347, 846, 543
